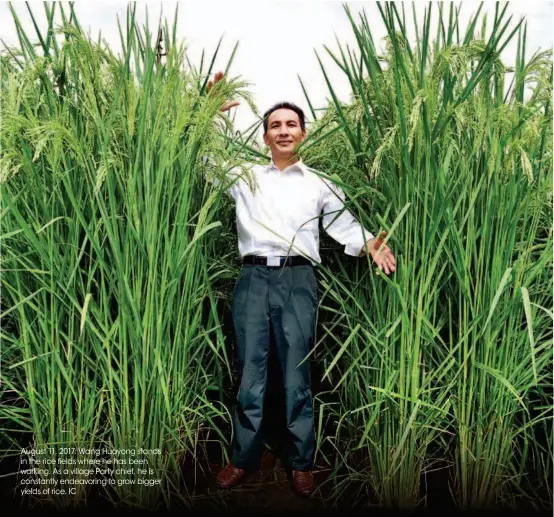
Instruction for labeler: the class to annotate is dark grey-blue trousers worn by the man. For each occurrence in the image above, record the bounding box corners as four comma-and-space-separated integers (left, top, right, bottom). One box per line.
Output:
231, 265, 317, 470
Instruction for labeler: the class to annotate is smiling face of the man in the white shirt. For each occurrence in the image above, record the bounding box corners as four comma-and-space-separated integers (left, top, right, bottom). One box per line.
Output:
264, 108, 306, 158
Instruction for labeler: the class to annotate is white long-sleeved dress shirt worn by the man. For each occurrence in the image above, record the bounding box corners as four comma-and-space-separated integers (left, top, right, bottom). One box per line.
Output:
209, 160, 374, 264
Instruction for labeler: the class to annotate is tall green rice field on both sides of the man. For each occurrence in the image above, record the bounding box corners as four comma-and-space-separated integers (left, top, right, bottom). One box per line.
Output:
0, 2, 553, 511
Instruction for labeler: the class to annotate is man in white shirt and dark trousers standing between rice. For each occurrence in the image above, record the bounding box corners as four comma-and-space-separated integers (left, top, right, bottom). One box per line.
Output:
208, 72, 396, 496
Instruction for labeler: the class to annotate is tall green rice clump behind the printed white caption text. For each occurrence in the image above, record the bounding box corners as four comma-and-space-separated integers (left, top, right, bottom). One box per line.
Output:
0, 3, 255, 507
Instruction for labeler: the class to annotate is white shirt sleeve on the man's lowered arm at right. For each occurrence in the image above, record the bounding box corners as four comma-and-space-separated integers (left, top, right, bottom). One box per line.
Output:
321, 181, 375, 257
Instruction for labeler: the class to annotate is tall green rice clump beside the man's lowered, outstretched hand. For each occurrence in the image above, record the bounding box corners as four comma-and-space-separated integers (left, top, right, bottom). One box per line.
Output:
303, 3, 552, 508
